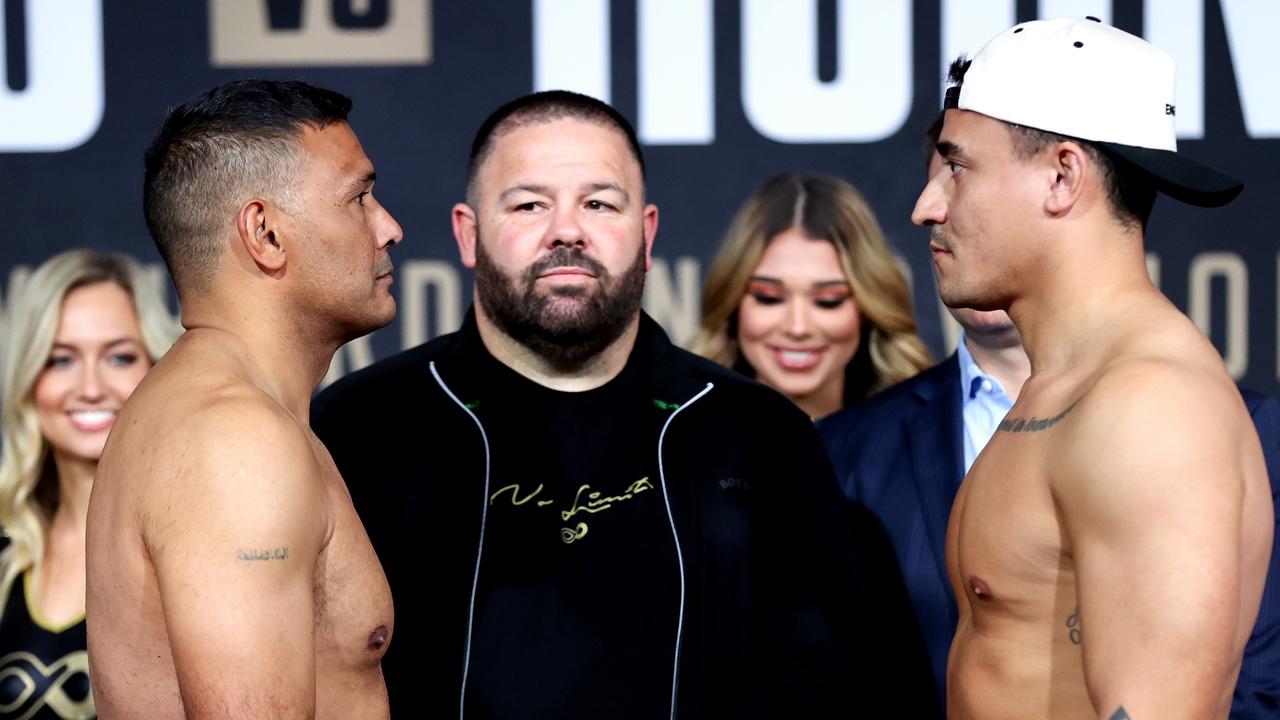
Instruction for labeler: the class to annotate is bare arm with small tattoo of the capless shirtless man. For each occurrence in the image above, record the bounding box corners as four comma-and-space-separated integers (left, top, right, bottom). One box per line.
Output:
142, 401, 328, 720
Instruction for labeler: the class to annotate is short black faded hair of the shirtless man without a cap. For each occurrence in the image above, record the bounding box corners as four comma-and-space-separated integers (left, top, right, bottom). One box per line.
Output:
142, 79, 351, 296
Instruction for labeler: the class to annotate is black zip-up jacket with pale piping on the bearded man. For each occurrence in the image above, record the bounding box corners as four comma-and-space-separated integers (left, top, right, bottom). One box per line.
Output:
312, 313, 933, 719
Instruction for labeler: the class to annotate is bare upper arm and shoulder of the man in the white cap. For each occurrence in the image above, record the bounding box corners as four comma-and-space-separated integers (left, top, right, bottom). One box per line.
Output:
1052, 365, 1261, 719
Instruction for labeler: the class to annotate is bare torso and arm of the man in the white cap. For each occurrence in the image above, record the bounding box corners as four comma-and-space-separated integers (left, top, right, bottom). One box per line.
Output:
946, 299, 1274, 720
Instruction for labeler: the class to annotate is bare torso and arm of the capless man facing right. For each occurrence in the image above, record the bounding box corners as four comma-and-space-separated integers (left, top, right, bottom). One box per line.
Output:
87, 332, 393, 720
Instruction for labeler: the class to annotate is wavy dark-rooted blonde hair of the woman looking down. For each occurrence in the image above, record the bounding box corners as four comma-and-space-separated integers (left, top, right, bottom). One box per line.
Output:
690, 173, 933, 407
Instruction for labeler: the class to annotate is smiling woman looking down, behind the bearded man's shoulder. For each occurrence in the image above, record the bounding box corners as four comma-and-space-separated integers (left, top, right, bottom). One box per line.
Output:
691, 173, 932, 419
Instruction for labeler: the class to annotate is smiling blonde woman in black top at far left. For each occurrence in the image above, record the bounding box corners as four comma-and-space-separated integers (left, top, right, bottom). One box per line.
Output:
0, 250, 180, 720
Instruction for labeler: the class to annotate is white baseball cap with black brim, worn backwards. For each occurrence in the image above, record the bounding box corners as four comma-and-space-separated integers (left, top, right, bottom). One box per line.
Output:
945, 17, 1244, 208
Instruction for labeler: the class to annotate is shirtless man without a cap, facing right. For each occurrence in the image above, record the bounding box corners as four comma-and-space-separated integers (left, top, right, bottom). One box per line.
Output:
87, 81, 401, 720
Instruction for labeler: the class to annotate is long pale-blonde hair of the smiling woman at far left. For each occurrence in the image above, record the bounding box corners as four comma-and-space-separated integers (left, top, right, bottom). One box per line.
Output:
0, 250, 182, 619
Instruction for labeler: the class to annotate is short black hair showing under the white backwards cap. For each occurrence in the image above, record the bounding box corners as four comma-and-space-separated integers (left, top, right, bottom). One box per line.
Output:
938, 55, 1156, 229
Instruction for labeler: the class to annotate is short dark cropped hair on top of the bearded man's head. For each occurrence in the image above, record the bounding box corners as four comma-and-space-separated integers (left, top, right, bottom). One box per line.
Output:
467, 90, 645, 205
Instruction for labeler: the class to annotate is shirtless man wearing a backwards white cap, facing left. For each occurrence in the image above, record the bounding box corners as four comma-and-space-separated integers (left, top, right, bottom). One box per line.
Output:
913, 18, 1274, 720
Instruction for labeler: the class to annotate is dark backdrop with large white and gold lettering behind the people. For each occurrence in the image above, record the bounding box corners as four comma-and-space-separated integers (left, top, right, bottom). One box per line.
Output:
0, 0, 1280, 395
